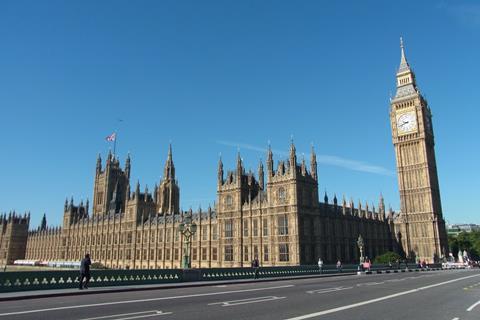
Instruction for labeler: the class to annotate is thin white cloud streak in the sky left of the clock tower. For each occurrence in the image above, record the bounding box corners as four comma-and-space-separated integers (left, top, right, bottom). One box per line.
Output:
215, 140, 395, 176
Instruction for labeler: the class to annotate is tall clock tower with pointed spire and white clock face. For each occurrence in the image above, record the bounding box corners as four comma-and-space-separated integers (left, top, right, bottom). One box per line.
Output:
390, 38, 448, 262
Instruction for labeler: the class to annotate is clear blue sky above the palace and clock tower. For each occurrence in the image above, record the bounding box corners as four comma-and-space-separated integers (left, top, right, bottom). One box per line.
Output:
0, 0, 480, 226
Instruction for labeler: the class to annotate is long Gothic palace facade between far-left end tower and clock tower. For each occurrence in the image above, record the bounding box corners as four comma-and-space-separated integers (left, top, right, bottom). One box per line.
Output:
21, 143, 396, 268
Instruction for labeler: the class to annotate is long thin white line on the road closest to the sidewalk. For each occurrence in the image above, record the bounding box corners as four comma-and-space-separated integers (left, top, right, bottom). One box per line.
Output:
0, 284, 294, 317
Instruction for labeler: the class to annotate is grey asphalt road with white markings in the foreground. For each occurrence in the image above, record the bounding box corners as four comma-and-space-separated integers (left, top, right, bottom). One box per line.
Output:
0, 269, 480, 320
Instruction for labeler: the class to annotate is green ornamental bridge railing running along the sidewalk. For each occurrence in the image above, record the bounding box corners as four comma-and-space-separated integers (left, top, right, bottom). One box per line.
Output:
0, 264, 441, 293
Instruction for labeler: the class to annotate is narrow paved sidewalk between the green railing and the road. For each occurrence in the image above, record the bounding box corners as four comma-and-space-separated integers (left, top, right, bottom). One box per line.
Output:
0, 272, 357, 301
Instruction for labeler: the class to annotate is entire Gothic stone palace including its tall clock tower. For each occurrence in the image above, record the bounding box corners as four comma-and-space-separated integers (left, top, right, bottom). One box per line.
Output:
0, 43, 447, 269
